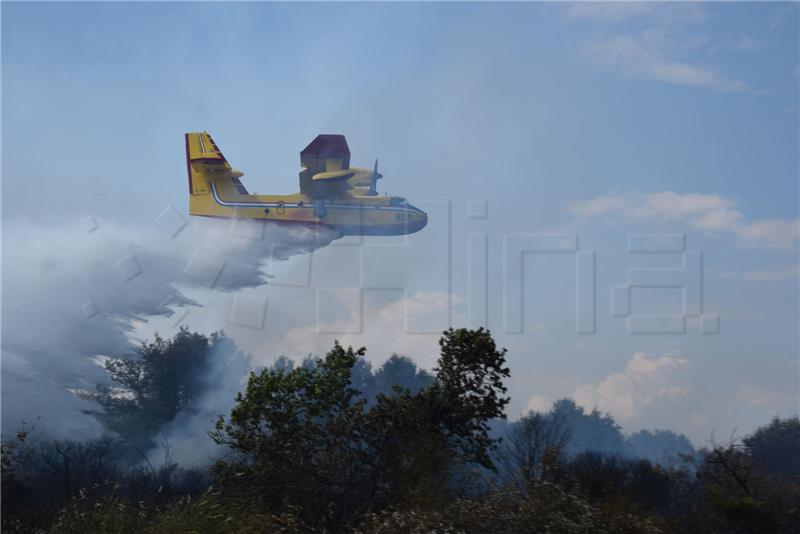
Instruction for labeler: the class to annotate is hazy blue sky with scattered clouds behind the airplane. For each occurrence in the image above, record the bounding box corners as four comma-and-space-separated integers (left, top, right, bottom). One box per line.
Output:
2, 3, 800, 443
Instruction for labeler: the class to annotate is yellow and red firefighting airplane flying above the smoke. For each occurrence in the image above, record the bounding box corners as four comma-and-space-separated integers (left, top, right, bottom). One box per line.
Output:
186, 132, 428, 235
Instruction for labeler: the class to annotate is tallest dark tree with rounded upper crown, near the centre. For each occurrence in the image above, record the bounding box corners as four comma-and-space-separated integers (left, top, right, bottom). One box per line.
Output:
366, 328, 509, 502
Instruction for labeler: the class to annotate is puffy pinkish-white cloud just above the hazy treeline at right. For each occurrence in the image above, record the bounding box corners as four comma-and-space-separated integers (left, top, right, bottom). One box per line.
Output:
573, 352, 689, 422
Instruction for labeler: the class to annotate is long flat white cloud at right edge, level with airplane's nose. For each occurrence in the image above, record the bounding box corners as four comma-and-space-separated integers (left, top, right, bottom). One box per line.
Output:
568, 191, 800, 250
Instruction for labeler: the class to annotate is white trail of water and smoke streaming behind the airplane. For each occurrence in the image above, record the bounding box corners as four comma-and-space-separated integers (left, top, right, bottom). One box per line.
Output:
1, 215, 338, 448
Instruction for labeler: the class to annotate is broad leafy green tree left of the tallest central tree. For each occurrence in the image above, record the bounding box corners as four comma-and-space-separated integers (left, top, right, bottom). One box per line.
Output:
212, 342, 369, 525
